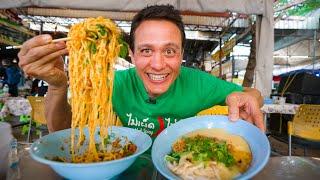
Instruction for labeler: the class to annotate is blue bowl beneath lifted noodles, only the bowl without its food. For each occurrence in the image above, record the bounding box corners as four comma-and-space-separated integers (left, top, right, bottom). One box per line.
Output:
30, 127, 152, 180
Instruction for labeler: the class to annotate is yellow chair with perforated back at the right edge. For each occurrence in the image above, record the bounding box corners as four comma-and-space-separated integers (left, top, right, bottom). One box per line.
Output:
288, 104, 320, 156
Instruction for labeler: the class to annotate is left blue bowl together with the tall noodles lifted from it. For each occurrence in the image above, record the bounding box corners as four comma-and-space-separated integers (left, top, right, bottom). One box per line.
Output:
30, 17, 152, 179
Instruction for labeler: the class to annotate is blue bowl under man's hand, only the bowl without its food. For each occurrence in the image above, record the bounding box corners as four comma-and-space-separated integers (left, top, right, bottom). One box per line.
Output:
152, 116, 270, 179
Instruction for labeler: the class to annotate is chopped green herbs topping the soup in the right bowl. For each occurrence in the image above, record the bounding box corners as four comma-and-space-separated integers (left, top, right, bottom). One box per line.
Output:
165, 135, 235, 167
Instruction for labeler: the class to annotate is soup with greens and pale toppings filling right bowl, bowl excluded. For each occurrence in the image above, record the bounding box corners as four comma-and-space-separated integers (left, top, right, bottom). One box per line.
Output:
165, 128, 252, 179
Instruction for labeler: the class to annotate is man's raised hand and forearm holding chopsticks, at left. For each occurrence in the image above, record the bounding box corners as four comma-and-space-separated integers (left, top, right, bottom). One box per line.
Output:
18, 35, 71, 132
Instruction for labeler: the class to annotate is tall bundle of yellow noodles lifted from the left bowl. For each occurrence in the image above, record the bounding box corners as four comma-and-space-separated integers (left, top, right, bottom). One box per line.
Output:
67, 17, 135, 163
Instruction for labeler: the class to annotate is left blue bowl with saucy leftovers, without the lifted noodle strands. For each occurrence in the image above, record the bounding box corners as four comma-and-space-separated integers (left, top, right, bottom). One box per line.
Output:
30, 126, 152, 179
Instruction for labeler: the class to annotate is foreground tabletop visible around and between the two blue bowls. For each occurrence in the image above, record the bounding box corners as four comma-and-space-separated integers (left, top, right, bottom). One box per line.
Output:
8, 144, 320, 180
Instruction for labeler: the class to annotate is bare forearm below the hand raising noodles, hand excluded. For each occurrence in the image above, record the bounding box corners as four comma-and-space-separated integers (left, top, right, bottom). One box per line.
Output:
45, 86, 71, 132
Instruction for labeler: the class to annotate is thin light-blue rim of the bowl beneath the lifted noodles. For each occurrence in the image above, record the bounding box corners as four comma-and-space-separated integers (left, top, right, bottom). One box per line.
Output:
29, 126, 152, 167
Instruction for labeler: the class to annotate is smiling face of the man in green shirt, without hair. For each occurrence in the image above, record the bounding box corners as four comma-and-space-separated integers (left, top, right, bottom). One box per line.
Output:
130, 20, 183, 97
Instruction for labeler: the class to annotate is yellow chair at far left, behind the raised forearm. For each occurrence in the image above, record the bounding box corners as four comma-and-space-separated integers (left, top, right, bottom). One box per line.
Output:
27, 96, 47, 142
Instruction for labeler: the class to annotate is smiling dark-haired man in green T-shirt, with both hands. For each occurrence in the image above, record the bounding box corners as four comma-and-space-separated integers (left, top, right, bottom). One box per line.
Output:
19, 5, 264, 137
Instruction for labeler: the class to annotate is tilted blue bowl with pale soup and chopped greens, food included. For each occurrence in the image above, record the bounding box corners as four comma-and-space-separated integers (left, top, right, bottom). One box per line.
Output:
152, 115, 270, 180
